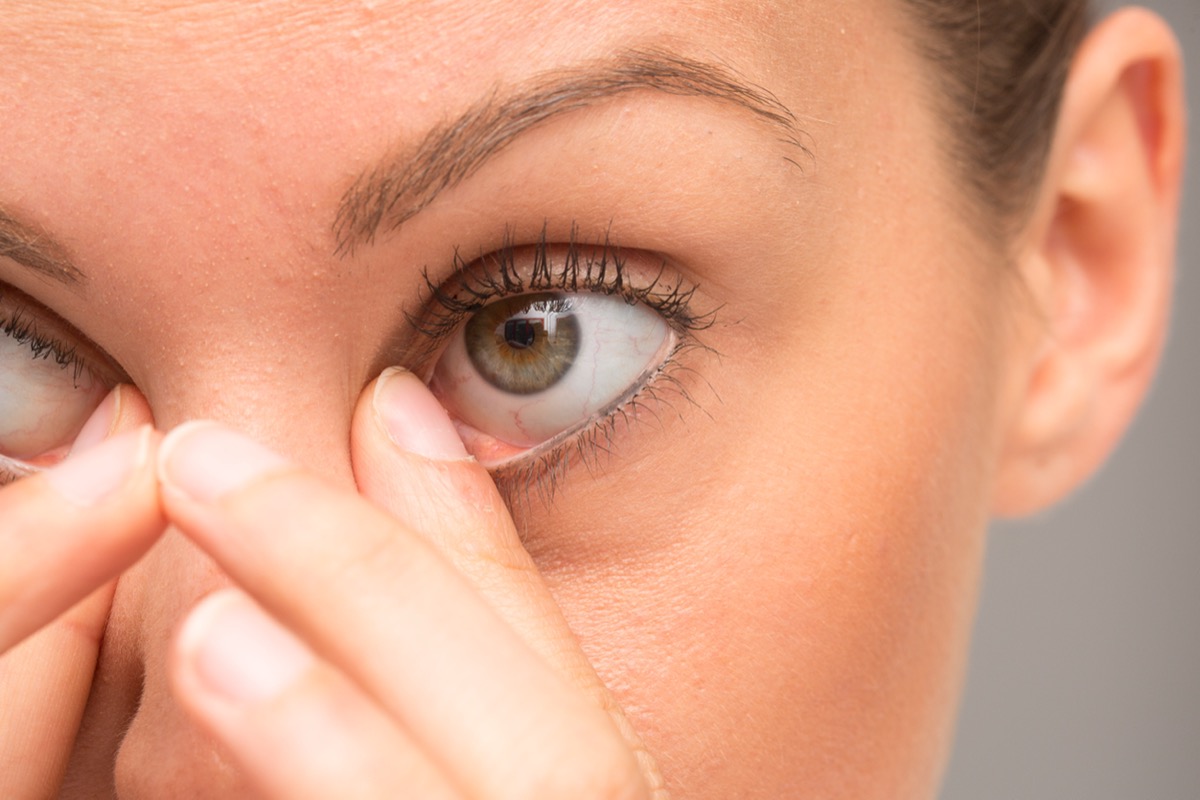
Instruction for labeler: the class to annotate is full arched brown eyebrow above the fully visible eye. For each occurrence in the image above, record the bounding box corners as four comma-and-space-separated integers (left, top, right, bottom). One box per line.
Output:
334, 50, 811, 254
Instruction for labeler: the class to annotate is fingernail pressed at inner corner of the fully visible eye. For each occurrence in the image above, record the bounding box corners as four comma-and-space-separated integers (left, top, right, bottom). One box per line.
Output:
374, 367, 468, 461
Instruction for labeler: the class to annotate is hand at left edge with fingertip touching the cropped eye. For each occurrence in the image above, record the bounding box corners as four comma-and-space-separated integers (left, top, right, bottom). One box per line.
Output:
0, 386, 164, 800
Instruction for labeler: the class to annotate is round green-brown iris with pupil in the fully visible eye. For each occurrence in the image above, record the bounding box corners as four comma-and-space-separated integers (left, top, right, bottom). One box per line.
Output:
464, 293, 580, 395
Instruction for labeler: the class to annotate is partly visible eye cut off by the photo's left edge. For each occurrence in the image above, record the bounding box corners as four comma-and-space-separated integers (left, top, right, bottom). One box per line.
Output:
0, 285, 120, 486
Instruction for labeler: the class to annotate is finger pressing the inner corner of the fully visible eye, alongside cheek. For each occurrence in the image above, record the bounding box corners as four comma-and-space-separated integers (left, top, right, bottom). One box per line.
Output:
350, 368, 666, 798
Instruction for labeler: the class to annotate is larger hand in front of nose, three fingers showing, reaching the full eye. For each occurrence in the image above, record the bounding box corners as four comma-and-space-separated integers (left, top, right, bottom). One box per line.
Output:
153, 372, 661, 800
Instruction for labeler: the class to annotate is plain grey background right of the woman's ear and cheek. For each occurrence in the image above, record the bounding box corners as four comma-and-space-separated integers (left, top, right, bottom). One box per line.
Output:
942, 0, 1200, 800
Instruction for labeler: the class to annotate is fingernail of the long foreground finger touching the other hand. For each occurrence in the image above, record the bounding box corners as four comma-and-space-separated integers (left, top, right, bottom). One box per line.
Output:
158, 421, 290, 503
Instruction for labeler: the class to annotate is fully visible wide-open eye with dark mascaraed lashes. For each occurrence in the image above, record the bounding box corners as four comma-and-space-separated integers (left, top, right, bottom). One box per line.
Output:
409, 226, 713, 500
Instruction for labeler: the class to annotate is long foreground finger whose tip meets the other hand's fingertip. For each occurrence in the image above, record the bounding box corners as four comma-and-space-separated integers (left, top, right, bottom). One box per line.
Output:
160, 423, 642, 799
